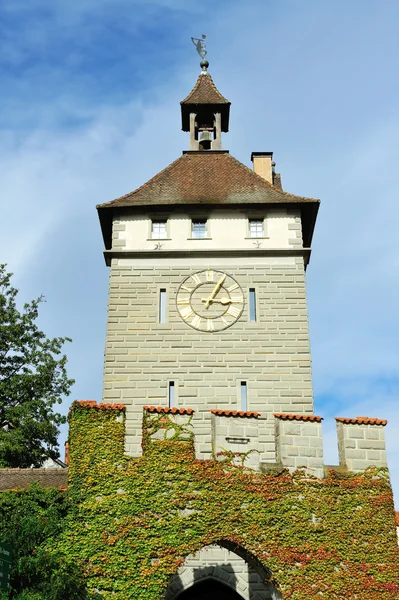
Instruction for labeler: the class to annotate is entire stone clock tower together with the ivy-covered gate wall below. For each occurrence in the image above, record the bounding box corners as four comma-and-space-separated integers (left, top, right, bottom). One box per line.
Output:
50, 40, 399, 600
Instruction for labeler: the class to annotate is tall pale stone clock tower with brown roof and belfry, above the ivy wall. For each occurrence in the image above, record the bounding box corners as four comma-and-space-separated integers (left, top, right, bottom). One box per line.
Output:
98, 60, 322, 468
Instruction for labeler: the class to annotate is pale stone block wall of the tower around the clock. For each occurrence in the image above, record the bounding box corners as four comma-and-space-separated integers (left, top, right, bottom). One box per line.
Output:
103, 252, 313, 461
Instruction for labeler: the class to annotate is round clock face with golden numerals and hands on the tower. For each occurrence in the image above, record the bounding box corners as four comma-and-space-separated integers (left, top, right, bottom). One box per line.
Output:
176, 270, 244, 333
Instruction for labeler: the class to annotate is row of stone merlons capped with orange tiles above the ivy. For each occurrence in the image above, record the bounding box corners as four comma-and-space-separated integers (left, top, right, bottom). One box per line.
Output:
69, 401, 387, 478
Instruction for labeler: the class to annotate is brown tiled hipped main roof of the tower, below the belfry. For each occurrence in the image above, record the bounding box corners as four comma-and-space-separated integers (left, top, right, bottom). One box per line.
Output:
97, 151, 319, 209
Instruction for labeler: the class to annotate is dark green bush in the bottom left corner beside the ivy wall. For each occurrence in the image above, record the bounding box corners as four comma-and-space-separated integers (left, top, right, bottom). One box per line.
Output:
0, 485, 87, 600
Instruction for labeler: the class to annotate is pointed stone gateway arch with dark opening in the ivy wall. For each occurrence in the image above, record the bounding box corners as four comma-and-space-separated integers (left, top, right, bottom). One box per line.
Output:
164, 539, 282, 600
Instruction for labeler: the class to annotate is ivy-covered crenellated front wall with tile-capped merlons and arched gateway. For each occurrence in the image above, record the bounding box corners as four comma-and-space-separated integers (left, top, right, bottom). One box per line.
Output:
59, 401, 399, 600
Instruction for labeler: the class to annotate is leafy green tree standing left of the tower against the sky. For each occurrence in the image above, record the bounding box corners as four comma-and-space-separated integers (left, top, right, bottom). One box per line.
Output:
0, 265, 74, 468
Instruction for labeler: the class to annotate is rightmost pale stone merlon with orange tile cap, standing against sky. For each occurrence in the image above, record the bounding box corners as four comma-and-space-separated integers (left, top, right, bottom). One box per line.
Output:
335, 417, 387, 472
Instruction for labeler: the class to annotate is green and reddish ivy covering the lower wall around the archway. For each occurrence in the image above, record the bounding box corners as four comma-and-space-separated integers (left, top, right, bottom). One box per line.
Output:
58, 402, 399, 600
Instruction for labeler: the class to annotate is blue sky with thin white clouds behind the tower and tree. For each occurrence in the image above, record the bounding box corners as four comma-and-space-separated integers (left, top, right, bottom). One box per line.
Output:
0, 0, 399, 498
